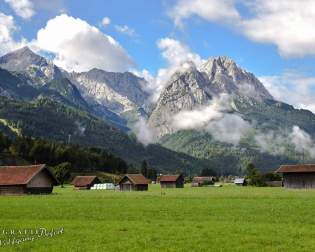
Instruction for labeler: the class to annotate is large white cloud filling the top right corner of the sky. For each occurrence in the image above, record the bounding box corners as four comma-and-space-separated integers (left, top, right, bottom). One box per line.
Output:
171, 0, 315, 57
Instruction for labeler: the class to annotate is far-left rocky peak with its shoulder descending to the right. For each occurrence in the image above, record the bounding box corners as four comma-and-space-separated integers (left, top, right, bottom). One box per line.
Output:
0, 47, 129, 131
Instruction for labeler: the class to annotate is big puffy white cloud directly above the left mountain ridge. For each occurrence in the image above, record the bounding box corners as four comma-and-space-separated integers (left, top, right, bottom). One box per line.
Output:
33, 14, 134, 72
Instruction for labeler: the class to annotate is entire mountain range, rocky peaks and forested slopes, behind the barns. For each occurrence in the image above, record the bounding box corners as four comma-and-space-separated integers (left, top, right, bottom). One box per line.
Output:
0, 47, 315, 174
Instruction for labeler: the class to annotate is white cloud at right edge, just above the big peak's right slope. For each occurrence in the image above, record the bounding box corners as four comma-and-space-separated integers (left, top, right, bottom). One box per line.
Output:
259, 71, 315, 113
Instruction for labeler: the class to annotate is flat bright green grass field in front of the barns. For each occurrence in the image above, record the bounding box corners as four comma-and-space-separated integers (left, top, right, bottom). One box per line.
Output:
0, 185, 315, 251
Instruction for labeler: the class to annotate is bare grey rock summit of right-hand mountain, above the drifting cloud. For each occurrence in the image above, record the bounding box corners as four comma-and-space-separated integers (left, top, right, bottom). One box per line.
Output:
148, 57, 273, 136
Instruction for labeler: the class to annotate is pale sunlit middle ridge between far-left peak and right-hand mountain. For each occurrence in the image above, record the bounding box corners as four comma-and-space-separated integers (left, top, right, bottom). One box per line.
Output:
69, 69, 149, 124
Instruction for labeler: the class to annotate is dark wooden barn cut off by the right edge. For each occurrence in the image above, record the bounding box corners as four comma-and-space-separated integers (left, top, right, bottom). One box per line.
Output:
277, 164, 315, 189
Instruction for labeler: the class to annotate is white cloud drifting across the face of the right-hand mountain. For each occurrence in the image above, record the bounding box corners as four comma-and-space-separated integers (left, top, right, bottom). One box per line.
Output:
172, 94, 253, 145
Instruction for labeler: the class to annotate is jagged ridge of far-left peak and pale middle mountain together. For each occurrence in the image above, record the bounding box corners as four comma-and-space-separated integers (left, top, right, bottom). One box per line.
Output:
0, 47, 151, 130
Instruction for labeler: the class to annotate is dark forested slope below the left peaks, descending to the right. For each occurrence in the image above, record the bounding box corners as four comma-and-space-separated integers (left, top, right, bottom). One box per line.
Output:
0, 97, 204, 171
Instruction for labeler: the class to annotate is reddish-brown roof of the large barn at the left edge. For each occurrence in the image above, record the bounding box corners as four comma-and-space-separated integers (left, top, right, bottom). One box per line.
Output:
0, 164, 57, 185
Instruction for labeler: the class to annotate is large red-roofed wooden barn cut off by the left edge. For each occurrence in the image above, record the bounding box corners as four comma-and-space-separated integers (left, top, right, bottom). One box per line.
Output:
0, 164, 57, 195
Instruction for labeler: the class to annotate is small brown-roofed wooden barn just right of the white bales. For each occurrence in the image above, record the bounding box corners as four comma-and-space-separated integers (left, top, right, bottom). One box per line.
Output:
119, 174, 149, 191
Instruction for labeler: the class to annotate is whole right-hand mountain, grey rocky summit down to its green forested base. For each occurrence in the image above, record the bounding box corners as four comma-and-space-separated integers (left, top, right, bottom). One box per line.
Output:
148, 57, 315, 171
